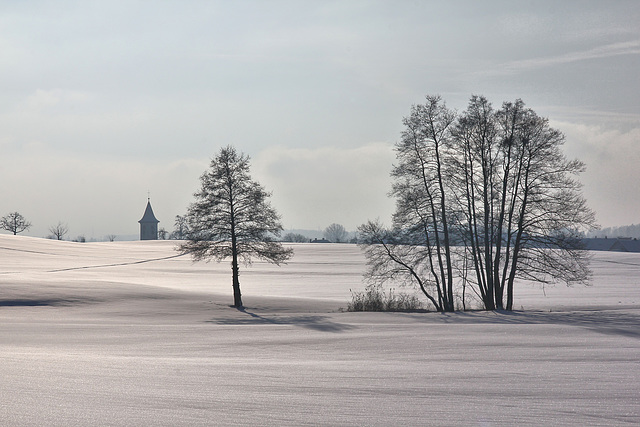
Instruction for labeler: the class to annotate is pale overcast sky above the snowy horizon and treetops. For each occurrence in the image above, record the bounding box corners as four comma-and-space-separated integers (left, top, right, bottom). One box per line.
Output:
0, 0, 640, 239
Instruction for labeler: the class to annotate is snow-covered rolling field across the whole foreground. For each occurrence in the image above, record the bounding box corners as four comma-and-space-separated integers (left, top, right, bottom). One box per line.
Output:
0, 235, 640, 426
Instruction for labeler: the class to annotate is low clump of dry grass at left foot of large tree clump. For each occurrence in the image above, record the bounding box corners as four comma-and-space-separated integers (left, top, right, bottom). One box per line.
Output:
347, 285, 423, 311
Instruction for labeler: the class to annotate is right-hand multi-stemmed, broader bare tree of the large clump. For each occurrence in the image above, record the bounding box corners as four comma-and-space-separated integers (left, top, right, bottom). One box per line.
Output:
453, 96, 595, 310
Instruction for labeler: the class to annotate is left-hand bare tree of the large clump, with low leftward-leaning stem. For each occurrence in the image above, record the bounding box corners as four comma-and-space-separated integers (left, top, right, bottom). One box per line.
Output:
359, 96, 455, 311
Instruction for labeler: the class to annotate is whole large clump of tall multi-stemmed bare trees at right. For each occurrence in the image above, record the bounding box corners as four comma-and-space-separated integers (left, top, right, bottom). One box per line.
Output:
359, 96, 594, 311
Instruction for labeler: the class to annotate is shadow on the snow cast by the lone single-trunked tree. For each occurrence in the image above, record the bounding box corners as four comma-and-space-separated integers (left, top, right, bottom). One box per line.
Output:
207, 307, 353, 332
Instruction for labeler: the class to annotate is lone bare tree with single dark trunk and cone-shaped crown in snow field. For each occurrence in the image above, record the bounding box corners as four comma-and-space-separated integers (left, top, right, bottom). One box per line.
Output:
179, 146, 293, 308
